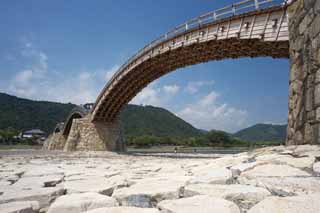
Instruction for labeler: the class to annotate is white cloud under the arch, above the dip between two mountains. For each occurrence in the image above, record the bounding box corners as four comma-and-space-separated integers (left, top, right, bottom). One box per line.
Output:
177, 91, 248, 132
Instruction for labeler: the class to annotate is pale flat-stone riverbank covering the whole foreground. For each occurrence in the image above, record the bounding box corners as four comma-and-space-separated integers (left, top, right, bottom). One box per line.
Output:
0, 145, 320, 213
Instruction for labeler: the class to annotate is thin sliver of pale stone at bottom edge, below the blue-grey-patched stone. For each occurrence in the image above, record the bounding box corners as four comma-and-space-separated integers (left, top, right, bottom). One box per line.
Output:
87, 206, 160, 213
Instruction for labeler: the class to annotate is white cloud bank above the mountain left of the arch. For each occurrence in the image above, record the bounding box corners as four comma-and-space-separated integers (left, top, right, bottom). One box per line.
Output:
6, 42, 105, 104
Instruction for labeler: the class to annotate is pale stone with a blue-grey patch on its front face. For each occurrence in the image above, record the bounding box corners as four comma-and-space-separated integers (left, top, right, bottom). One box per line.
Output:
112, 179, 185, 208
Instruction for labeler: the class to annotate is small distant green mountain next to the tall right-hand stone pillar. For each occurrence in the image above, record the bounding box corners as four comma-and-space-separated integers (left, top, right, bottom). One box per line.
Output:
233, 124, 287, 142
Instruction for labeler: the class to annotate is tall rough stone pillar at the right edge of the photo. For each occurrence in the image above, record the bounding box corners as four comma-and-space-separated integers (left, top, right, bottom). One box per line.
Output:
286, 0, 320, 145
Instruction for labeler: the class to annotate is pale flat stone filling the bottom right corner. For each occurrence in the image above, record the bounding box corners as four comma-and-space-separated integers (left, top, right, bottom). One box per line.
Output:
248, 194, 320, 213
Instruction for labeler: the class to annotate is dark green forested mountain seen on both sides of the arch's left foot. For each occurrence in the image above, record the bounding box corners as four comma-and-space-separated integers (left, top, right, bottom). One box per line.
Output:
0, 93, 202, 137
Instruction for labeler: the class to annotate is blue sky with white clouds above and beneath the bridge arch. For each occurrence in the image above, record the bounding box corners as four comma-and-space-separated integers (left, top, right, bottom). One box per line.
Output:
0, 0, 289, 132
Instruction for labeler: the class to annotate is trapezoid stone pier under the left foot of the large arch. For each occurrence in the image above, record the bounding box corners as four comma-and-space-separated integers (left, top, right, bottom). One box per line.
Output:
64, 115, 125, 152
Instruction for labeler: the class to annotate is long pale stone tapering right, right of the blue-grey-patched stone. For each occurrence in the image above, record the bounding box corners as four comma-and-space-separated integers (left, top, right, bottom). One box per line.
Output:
184, 184, 271, 210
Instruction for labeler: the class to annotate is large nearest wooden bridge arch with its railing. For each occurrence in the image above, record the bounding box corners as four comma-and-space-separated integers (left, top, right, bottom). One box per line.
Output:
91, 0, 289, 122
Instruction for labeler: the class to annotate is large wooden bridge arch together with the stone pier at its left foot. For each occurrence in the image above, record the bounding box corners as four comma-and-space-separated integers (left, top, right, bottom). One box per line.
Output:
45, 0, 320, 151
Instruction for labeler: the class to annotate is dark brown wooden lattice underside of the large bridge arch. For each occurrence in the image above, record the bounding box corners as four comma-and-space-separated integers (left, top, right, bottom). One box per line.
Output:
94, 38, 289, 122
